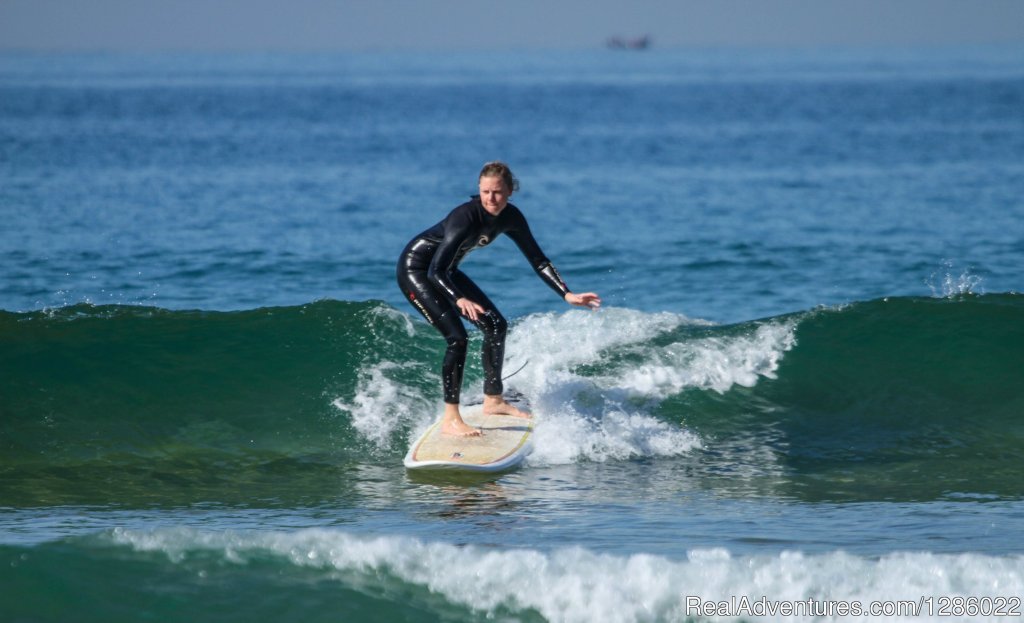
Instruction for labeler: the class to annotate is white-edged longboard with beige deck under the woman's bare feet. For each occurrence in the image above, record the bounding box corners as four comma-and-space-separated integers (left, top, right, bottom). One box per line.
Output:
403, 405, 534, 471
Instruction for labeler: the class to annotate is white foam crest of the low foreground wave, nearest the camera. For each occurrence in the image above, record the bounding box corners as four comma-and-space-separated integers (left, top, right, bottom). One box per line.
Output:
111, 529, 1024, 623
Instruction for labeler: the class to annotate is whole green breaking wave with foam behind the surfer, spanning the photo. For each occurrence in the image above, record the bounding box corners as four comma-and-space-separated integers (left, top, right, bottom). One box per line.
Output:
0, 294, 1024, 503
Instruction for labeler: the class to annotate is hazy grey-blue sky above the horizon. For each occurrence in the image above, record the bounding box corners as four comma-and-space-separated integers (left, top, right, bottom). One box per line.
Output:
0, 0, 1024, 50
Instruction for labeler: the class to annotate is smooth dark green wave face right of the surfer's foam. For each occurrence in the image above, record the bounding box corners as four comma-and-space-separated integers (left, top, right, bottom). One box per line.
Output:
659, 294, 1024, 499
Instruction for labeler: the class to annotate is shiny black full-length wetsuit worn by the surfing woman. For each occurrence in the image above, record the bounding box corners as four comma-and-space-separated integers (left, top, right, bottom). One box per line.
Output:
397, 197, 569, 405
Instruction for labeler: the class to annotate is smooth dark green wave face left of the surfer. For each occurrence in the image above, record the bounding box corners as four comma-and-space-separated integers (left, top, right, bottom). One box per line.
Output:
0, 301, 437, 504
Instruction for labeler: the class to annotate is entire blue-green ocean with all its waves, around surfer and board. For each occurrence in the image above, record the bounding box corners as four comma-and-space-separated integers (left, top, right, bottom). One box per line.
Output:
0, 46, 1024, 623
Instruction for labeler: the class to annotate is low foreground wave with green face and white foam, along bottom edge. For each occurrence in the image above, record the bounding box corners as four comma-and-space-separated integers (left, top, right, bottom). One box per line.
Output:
0, 528, 1024, 623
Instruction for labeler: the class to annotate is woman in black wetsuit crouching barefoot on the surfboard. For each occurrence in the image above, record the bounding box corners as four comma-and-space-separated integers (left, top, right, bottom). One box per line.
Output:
397, 162, 601, 435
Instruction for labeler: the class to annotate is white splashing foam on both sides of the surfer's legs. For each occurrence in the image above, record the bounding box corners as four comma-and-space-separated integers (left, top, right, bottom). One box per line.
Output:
334, 307, 796, 465
